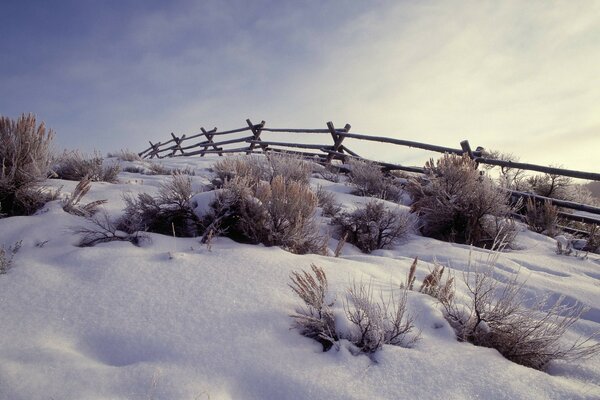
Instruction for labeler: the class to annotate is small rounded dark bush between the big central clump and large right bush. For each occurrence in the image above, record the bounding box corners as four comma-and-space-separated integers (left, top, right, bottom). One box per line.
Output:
333, 200, 414, 253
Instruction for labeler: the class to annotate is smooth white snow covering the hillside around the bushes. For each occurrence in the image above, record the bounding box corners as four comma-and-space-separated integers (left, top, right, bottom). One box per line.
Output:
0, 158, 600, 400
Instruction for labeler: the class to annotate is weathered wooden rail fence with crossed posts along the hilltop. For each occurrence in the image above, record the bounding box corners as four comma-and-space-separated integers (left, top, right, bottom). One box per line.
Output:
139, 119, 600, 230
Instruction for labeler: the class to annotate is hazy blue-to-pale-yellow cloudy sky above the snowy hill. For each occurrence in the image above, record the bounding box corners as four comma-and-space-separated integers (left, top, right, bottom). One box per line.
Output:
0, 0, 600, 172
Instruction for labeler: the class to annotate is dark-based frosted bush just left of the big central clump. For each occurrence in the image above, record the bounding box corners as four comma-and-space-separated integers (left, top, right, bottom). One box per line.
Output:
117, 175, 203, 237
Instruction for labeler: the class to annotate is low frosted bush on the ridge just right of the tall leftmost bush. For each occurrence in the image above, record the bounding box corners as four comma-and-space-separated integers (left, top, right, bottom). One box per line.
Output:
54, 151, 121, 183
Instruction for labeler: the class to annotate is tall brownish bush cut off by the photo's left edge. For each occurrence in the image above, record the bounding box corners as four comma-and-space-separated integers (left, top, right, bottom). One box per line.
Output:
0, 114, 54, 216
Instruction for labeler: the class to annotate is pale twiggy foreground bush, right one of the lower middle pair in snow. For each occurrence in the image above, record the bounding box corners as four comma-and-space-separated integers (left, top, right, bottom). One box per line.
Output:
344, 283, 419, 353
